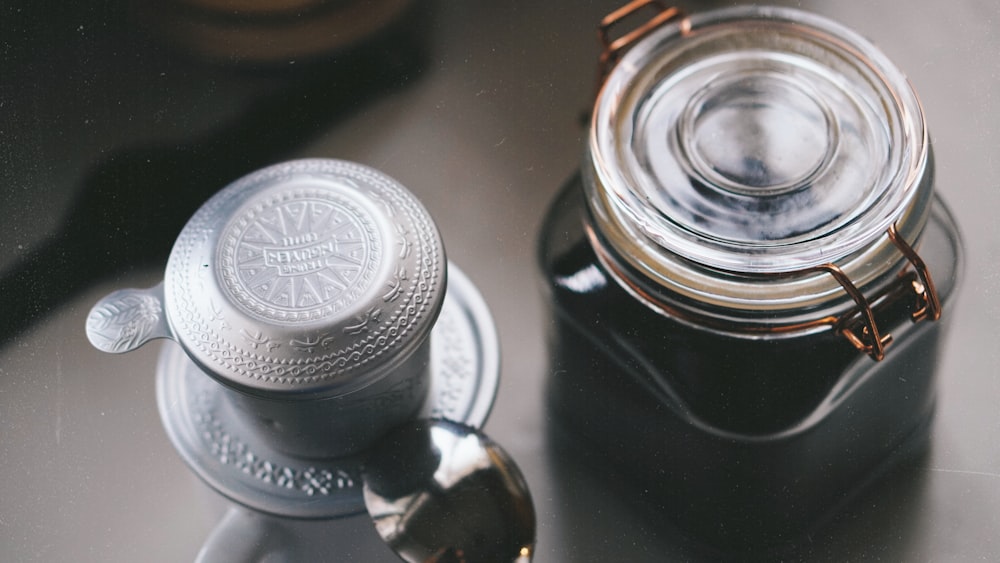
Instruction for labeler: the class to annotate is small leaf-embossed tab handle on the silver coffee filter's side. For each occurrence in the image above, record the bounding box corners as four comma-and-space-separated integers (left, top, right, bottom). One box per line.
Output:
87, 283, 174, 354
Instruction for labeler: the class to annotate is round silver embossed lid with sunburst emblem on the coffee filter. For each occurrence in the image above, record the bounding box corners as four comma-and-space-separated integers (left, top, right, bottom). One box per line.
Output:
164, 159, 446, 398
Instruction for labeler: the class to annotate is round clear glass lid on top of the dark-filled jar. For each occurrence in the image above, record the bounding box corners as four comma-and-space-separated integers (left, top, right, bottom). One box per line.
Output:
588, 7, 927, 274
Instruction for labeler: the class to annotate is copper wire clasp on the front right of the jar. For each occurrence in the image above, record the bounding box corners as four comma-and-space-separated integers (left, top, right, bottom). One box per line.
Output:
814, 223, 941, 362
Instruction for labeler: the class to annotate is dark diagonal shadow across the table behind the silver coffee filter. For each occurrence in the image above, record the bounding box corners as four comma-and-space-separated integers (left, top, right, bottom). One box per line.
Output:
0, 0, 429, 344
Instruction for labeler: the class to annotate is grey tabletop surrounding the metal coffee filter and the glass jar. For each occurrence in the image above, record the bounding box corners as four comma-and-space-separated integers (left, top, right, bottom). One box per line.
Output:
0, 0, 1000, 562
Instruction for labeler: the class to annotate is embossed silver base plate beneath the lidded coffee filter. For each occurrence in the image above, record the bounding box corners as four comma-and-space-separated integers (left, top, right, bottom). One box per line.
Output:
156, 264, 500, 518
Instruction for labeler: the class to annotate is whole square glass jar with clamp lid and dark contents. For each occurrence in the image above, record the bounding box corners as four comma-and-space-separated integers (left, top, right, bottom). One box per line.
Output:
539, 2, 962, 547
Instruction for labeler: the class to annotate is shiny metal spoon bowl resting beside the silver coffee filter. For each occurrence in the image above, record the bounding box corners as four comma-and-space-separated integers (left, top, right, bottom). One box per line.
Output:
363, 420, 535, 563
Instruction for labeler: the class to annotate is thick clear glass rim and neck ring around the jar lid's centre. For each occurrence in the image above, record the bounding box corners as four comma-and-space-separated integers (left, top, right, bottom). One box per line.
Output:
584, 6, 933, 320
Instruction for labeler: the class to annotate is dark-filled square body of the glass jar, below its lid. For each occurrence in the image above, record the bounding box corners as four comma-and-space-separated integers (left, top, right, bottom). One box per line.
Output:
540, 178, 958, 550
